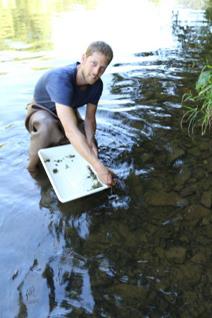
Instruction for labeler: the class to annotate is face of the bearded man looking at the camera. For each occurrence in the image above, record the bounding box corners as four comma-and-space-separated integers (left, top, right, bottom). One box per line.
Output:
81, 52, 108, 85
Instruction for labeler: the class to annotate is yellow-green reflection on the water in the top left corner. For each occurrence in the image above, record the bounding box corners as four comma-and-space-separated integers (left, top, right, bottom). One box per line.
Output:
0, 1, 51, 50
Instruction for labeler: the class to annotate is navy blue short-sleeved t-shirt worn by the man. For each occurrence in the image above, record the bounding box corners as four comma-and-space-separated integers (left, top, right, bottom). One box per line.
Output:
34, 62, 103, 112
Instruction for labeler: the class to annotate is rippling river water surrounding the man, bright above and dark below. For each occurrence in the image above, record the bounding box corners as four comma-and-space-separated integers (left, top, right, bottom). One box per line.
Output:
0, 0, 212, 318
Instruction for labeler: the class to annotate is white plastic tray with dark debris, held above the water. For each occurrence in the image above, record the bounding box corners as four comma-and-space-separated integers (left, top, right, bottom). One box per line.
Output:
38, 144, 108, 203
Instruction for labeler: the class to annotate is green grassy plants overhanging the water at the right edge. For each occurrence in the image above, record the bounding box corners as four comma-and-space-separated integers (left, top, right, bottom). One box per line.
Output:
181, 65, 212, 135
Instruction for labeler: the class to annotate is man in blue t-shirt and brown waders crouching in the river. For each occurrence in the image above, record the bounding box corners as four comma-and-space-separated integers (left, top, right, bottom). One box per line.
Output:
25, 41, 117, 186
